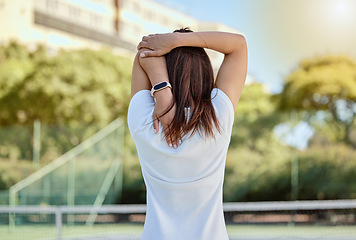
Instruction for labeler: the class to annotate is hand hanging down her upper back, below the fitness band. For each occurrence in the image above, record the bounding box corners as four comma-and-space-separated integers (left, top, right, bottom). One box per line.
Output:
152, 89, 181, 148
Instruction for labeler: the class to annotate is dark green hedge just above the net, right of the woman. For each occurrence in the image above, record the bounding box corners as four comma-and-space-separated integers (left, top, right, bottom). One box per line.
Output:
224, 141, 356, 202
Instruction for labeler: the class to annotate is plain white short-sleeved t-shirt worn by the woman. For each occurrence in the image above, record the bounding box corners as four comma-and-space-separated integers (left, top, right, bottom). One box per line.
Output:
128, 88, 234, 240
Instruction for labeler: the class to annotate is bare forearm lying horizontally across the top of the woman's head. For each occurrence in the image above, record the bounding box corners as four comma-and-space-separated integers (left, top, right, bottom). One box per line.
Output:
174, 32, 246, 54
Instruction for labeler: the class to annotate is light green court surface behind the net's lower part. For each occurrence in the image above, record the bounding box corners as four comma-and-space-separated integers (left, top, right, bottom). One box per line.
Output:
0, 225, 356, 240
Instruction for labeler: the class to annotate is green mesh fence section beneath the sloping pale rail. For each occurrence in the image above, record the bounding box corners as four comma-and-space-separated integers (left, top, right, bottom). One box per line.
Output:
9, 119, 124, 206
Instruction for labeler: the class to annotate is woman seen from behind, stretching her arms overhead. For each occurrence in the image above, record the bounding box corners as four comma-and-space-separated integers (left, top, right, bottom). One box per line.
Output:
128, 29, 247, 240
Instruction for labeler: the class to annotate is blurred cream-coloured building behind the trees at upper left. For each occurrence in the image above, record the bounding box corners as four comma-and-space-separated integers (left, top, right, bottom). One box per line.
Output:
0, 0, 242, 66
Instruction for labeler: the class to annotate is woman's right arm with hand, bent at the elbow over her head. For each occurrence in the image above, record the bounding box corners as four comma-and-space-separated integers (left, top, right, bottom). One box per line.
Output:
138, 32, 247, 109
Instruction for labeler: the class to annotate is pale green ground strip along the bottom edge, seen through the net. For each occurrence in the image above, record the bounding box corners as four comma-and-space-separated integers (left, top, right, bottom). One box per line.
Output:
0, 224, 356, 240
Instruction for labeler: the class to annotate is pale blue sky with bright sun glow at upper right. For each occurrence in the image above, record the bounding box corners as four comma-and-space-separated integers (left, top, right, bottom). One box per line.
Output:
155, 0, 356, 93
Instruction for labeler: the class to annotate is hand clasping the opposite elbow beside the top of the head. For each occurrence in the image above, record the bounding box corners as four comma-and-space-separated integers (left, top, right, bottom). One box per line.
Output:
137, 33, 177, 57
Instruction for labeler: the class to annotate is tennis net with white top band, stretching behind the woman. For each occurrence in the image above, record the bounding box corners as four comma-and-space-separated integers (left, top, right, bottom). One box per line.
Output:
0, 200, 356, 240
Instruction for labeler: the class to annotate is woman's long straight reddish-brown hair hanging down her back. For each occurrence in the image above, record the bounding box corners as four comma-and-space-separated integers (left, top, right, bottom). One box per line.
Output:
165, 28, 220, 142
